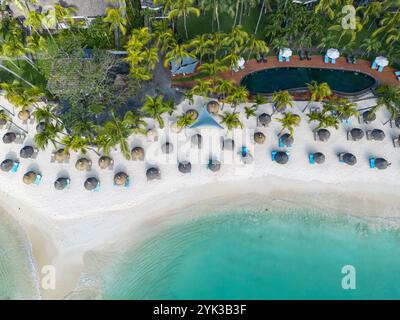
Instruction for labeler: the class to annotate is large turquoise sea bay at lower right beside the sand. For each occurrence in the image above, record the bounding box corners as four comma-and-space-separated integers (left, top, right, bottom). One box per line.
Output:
95, 208, 400, 299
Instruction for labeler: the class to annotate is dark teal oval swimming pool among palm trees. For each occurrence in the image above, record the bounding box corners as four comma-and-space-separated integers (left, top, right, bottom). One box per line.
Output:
241, 68, 376, 94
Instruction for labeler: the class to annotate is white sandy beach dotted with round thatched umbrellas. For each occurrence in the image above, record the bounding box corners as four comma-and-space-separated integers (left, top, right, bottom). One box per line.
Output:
0, 97, 400, 299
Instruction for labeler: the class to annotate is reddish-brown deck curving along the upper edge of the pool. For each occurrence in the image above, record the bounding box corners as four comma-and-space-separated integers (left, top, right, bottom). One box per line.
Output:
173, 55, 400, 88
